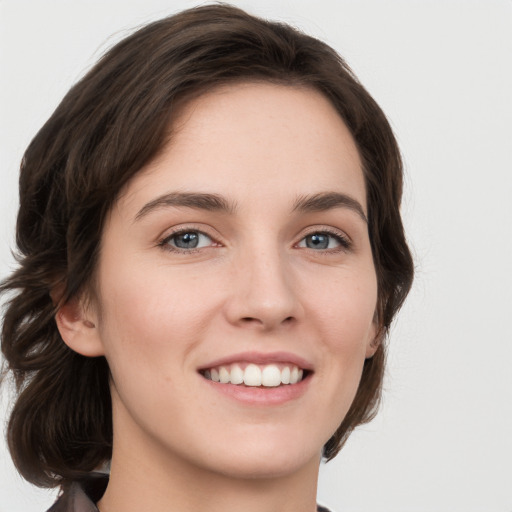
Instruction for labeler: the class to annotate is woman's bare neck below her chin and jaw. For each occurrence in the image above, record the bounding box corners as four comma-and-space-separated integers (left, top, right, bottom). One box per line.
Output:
98, 420, 320, 512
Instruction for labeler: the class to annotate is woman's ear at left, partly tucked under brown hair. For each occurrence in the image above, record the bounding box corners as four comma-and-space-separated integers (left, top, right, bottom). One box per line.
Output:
51, 293, 105, 357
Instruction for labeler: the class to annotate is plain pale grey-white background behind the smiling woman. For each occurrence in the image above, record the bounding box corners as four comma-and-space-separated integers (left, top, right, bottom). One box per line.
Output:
0, 0, 512, 512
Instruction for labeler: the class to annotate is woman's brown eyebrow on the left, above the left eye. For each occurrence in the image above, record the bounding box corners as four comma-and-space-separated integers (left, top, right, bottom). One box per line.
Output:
135, 192, 237, 221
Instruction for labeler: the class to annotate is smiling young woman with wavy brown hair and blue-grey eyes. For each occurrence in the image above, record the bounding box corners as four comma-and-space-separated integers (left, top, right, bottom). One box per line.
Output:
1, 5, 413, 512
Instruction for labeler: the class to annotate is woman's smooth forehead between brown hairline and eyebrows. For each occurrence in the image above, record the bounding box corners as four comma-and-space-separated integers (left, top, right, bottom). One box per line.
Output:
118, 83, 366, 216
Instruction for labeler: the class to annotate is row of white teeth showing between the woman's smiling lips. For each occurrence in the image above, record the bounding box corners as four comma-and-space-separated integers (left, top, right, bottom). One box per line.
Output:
200, 363, 311, 388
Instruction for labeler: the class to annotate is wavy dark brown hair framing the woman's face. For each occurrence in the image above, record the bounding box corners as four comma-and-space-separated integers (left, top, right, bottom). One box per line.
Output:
0, 5, 413, 486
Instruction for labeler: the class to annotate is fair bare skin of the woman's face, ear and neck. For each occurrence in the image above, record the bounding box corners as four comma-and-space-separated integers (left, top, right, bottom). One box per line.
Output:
57, 83, 377, 512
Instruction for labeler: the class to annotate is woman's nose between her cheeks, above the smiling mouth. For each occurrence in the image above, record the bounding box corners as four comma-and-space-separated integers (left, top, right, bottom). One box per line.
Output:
226, 248, 303, 331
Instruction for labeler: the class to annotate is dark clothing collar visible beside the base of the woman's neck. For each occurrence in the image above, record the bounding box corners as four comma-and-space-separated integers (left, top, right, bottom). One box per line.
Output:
48, 473, 329, 512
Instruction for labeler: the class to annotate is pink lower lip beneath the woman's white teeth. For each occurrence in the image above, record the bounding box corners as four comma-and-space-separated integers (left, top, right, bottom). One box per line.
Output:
201, 374, 312, 406
